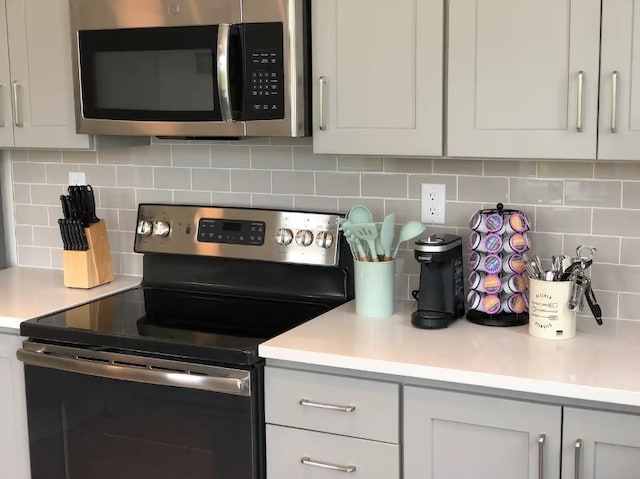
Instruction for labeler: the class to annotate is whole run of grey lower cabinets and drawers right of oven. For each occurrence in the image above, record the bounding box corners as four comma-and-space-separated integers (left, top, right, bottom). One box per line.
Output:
264, 366, 640, 479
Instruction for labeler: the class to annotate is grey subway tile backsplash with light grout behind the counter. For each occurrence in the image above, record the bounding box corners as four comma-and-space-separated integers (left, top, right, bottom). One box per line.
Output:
8, 138, 640, 320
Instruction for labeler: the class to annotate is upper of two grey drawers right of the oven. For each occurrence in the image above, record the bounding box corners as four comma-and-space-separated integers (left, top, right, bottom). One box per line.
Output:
265, 367, 399, 443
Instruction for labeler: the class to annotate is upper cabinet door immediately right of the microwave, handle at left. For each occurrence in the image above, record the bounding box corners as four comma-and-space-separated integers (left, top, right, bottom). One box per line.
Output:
312, 0, 444, 156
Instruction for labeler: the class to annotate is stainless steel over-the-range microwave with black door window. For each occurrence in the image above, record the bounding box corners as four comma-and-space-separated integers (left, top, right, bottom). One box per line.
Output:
70, 0, 311, 138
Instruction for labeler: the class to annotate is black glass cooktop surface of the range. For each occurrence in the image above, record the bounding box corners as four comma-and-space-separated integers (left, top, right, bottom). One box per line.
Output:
20, 287, 330, 364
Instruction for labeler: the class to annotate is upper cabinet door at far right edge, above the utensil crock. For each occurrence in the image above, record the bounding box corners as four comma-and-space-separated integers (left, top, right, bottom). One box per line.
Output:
598, 0, 640, 160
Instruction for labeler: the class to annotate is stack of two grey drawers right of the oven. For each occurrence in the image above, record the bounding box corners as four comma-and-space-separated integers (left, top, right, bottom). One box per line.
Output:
265, 367, 400, 479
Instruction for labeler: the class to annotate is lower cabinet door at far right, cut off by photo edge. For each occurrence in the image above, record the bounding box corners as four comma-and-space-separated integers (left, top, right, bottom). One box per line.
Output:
562, 407, 640, 479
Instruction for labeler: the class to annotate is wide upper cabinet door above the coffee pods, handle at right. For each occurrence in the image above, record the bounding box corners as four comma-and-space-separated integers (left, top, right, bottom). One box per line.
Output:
447, 0, 600, 159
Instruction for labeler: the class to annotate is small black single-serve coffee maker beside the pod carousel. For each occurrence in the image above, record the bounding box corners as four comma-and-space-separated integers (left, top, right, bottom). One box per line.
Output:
411, 234, 464, 329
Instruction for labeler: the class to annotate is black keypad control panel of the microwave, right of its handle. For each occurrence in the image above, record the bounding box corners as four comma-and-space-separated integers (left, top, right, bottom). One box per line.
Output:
244, 23, 285, 120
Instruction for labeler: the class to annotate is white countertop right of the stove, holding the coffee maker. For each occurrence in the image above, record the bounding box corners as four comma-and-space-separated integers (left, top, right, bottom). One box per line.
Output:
259, 301, 640, 406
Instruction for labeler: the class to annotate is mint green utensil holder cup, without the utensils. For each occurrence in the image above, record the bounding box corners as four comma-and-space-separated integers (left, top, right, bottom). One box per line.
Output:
354, 260, 396, 318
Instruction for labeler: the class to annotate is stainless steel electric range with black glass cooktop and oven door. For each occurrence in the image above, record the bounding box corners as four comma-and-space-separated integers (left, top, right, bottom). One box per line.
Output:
18, 204, 353, 479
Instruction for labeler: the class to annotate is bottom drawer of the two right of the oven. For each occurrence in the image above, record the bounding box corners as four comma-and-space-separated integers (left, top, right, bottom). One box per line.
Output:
267, 424, 400, 479
